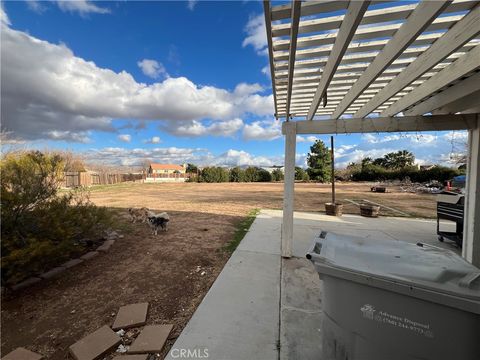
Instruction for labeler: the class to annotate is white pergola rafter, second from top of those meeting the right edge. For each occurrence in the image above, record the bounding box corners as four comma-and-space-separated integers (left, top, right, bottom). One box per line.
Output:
382, 44, 480, 116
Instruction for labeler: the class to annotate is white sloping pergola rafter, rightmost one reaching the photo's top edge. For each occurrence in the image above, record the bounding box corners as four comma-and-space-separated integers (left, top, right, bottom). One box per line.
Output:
333, 1, 450, 119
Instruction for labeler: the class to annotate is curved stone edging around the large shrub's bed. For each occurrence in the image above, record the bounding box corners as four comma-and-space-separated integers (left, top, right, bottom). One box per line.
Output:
9, 231, 123, 293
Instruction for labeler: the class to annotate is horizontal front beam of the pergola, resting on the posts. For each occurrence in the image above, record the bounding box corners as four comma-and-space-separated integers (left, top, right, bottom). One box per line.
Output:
282, 114, 480, 134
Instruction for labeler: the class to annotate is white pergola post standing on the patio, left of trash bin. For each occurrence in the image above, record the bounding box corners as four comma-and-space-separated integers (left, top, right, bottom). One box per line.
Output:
282, 121, 297, 258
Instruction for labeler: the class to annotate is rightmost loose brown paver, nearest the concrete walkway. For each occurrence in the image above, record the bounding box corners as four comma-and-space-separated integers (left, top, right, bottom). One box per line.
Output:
128, 325, 173, 354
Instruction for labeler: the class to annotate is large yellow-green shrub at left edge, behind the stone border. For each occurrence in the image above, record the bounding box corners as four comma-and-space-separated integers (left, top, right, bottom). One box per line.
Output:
1, 151, 110, 285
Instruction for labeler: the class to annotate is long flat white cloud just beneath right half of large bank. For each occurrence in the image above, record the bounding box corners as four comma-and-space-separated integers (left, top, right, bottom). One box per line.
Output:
162, 118, 243, 137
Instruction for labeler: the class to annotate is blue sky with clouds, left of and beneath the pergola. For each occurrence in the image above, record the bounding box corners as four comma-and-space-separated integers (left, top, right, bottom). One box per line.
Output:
1, 1, 465, 167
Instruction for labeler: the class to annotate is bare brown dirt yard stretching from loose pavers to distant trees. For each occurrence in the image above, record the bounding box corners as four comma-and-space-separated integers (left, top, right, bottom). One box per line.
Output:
1, 183, 435, 359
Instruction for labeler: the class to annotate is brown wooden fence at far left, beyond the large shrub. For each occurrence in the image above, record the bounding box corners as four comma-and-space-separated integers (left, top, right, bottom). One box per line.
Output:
62, 171, 144, 187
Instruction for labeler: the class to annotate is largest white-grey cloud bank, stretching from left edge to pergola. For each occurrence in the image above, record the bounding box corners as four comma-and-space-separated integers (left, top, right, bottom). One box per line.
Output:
1, 24, 273, 139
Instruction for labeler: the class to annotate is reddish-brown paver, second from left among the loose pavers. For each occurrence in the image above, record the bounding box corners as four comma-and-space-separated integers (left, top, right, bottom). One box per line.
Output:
69, 325, 122, 360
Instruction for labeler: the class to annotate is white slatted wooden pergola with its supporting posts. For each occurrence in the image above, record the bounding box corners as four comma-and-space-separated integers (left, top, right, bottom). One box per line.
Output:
264, 0, 480, 266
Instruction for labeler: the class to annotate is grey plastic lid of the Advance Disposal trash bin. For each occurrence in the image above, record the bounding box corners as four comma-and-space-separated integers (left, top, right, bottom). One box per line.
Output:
307, 231, 480, 314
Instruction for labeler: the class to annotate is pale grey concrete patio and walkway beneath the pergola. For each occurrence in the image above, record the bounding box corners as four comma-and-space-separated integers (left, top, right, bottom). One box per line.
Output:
166, 210, 459, 360
